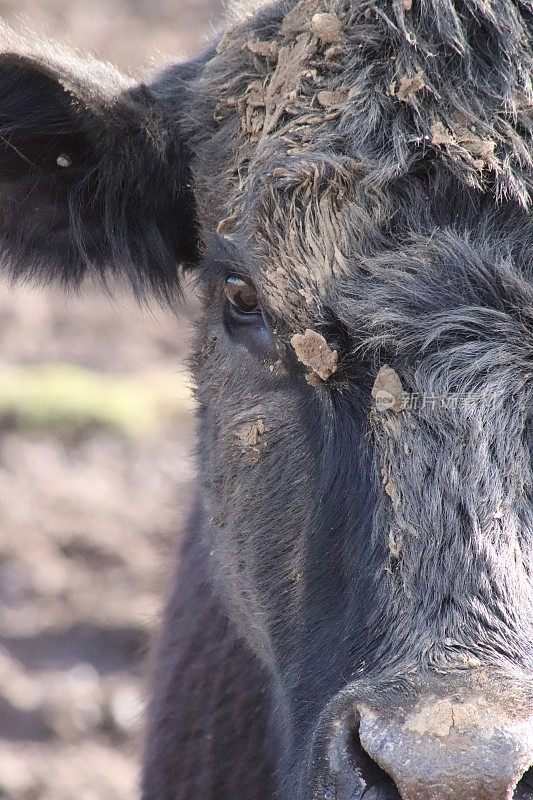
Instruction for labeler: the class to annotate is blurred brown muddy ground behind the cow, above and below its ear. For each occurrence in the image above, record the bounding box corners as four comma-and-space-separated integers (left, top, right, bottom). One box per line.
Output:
0, 0, 221, 800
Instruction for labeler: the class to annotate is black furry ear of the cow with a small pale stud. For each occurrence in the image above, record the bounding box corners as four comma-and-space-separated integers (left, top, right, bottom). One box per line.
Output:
0, 32, 197, 300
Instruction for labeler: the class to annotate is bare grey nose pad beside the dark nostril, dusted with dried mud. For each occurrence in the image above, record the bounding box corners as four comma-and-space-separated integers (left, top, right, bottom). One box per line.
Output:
359, 697, 533, 800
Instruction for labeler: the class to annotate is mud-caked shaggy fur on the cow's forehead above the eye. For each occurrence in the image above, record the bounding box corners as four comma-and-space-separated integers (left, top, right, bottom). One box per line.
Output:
188, 0, 533, 319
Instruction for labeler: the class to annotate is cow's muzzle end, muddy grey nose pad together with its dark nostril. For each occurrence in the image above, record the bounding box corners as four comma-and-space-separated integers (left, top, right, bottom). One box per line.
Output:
307, 689, 533, 800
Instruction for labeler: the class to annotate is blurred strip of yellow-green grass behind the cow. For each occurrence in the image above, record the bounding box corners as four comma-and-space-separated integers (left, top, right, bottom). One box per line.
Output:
0, 364, 192, 437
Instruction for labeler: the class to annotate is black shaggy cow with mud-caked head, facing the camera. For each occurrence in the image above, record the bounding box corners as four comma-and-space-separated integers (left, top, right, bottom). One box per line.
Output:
0, 0, 533, 800
